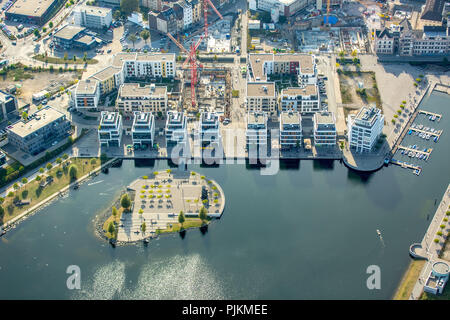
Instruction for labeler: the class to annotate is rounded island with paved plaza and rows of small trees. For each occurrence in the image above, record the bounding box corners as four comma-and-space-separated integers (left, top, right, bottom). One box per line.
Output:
103, 169, 225, 244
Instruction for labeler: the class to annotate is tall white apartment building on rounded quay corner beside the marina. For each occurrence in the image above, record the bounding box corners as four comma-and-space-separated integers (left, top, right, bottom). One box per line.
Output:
347, 107, 384, 152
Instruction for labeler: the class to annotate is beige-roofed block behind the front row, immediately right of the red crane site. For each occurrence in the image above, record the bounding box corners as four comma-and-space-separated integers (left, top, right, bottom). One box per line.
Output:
246, 82, 278, 118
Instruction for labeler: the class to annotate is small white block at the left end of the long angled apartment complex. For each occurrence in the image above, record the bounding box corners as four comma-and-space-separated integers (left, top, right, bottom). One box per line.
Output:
72, 79, 100, 109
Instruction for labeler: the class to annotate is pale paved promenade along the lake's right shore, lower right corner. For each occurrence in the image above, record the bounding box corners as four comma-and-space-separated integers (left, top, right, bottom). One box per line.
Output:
409, 185, 450, 300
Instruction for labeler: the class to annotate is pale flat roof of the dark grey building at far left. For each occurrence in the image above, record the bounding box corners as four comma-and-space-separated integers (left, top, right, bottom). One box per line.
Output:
9, 106, 65, 138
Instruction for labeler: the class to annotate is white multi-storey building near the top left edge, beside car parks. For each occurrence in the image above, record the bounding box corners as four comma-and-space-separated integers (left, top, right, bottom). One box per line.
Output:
73, 6, 112, 29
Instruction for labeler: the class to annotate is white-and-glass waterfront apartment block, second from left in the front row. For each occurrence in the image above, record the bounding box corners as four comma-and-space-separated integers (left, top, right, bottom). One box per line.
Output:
131, 111, 155, 147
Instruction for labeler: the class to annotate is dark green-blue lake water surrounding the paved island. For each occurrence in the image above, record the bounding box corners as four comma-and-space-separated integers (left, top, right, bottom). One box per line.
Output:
0, 93, 450, 299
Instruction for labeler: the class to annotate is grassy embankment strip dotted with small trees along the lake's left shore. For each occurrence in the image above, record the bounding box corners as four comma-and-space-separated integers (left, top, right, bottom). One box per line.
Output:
0, 158, 101, 224
